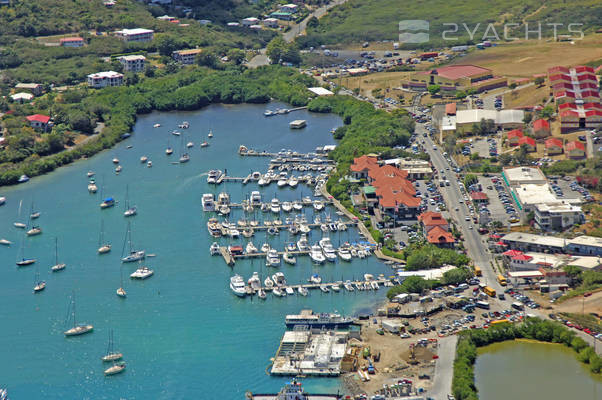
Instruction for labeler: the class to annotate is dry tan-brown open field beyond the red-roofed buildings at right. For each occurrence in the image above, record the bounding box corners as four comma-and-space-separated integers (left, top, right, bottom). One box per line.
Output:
454, 35, 602, 78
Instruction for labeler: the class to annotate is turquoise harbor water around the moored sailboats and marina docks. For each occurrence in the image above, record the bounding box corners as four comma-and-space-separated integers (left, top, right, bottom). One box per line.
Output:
0, 104, 389, 399
